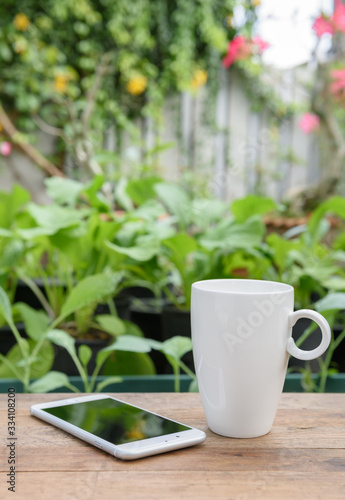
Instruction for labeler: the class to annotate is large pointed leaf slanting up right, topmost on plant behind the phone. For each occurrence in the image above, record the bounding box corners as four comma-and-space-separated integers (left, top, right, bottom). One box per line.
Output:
59, 273, 122, 320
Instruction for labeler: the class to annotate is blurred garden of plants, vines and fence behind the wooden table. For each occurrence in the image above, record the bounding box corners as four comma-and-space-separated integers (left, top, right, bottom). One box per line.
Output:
0, 0, 345, 391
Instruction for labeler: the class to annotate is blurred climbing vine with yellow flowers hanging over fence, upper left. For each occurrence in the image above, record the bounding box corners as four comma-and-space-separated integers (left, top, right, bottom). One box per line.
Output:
0, 0, 256, 178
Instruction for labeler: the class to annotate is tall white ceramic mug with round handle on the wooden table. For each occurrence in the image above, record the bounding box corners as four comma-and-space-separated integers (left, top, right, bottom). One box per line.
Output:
191, 279, 331, 438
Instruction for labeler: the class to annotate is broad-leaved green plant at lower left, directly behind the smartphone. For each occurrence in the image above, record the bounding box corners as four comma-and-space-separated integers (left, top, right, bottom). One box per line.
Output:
0, 273, 161, 391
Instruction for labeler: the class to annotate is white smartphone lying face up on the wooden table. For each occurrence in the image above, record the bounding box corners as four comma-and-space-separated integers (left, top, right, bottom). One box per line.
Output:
30, 394, 206, 460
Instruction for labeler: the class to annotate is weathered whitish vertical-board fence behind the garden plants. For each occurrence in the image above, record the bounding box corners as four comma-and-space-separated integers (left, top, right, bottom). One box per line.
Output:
0, 65, 322, 201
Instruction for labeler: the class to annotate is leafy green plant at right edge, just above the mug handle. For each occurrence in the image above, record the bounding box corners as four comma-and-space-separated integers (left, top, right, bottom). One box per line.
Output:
265, 197, 345, 308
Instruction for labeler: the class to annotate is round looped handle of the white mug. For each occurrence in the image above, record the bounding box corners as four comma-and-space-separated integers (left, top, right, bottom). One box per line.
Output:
286, 309, 331, 361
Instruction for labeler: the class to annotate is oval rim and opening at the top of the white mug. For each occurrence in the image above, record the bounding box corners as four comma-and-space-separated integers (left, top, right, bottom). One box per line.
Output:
192, 278, 294, 295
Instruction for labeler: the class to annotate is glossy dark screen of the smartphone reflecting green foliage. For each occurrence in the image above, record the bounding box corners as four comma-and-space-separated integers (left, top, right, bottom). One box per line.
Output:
42, 398, 190, 445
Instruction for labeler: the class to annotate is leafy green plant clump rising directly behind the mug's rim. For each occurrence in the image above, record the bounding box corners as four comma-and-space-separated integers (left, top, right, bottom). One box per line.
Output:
158, 192, 275, 310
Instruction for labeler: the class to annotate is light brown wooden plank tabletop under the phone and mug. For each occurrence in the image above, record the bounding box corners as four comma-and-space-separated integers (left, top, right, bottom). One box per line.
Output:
0, 393, 345, 500
